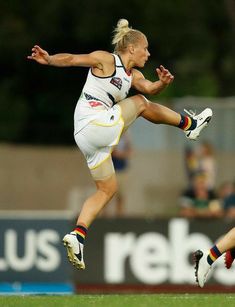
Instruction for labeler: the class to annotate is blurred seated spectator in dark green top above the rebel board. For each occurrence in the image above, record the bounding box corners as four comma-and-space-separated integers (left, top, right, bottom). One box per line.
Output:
180, 173, 223, 218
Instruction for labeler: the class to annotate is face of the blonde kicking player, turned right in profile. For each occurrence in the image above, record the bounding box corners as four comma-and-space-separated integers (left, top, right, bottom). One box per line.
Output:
133, 36, 150, 67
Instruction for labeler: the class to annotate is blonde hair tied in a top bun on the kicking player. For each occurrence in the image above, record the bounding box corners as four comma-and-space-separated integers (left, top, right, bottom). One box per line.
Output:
112, 19, 145, 53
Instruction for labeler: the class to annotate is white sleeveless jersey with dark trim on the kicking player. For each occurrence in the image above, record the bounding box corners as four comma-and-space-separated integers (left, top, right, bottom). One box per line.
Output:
74, 54, 132, 133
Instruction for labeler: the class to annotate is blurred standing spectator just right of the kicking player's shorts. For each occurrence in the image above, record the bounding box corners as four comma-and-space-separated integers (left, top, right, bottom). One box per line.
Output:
112, 131, 132, 216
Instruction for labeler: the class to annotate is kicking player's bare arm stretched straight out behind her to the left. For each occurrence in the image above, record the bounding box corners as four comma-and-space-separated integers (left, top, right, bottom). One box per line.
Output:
27, 45, 105, 69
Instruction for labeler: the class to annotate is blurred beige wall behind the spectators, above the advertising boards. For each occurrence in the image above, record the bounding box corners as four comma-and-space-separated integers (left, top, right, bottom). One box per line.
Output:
0, 144, 235, 216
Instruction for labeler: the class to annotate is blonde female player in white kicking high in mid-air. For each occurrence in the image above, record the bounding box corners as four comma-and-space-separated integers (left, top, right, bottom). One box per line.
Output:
28, 19, 212, 269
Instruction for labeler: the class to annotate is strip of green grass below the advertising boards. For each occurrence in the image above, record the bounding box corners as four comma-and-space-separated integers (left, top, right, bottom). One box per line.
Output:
0, 294, 235, 307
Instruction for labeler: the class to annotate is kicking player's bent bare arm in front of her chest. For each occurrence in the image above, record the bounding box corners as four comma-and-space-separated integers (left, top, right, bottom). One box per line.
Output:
132, 65, 174, 95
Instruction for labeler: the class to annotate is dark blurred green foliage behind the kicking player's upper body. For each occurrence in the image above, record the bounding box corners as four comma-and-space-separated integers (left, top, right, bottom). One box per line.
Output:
0, 0, 235, 144
